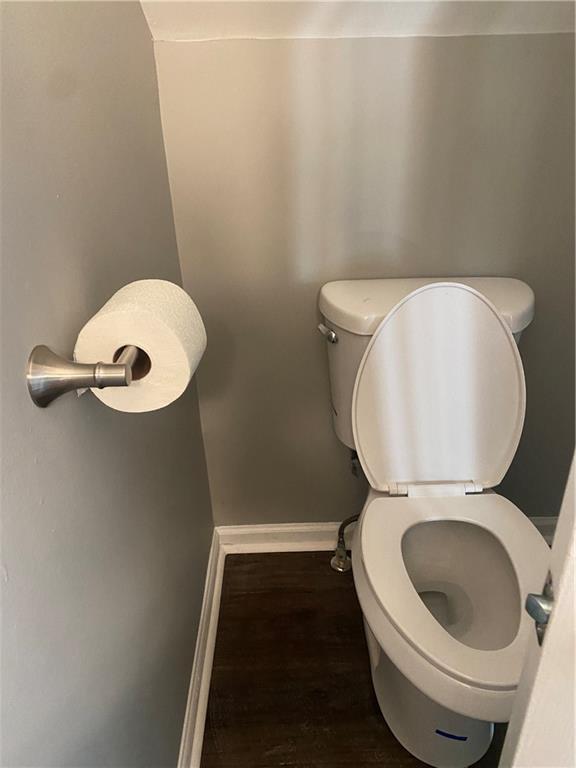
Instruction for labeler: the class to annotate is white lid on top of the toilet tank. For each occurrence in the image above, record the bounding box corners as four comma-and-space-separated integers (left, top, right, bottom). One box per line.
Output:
319, 277, 534, 336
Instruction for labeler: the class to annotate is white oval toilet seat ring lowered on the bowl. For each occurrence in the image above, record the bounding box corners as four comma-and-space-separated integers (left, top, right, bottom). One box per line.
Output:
359, 493, 548, 691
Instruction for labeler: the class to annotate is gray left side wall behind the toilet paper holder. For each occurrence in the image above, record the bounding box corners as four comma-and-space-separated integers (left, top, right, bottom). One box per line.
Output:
2, 2, 212, 768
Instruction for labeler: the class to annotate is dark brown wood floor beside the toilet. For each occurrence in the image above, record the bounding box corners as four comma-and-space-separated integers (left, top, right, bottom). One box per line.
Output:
202, 552, 504, 768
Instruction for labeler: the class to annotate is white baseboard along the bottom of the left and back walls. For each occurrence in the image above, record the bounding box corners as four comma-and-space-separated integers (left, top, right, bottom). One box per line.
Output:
178, 517, 558, 768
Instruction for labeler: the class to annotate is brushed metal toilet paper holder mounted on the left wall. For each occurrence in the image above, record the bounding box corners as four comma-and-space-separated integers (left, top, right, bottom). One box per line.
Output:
26, 344, 145, 408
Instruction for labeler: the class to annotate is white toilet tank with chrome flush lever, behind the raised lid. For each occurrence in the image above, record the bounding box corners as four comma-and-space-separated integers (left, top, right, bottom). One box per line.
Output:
319, 277, 534, 448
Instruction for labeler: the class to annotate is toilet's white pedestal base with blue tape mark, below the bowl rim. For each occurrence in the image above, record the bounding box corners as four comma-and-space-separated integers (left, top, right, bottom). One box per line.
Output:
364, 621, 494, 768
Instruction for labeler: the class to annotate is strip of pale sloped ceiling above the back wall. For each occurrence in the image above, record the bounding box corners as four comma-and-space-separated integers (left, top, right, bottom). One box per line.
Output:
142, 0, 574, 41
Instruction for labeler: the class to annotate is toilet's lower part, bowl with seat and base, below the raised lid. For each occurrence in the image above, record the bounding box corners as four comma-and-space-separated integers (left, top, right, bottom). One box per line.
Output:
352, 493, 549, 768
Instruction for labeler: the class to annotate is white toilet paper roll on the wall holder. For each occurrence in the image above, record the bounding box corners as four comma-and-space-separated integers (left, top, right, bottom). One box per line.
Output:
74, 280, 206, 413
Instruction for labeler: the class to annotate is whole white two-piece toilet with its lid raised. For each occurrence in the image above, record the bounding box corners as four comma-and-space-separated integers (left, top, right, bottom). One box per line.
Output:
320, 278, 549, 768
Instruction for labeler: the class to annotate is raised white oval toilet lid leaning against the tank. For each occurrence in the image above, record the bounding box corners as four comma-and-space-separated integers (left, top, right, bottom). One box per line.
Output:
352, 283, 526, 491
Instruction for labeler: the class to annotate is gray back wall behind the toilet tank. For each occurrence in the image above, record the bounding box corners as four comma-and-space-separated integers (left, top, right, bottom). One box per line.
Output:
155, 34, 574, 523
